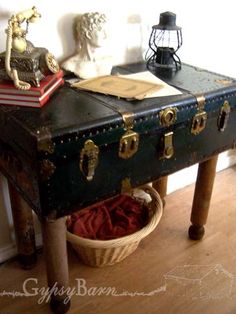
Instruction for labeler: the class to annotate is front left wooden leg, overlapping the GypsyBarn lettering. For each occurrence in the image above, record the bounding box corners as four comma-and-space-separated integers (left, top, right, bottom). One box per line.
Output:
42, 218, 70, 314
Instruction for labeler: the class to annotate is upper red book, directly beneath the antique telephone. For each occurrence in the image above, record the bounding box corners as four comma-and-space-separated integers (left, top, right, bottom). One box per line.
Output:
0, 70, 63, 96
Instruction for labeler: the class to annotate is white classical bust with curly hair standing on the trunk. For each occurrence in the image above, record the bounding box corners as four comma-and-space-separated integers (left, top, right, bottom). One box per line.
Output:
62, 12, 112, 79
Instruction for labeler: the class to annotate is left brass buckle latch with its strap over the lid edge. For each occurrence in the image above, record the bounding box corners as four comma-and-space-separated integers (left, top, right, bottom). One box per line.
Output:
119, 112, 139, 159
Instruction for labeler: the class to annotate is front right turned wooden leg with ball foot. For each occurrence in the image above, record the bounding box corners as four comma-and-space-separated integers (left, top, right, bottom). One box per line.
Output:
189, 155, 218, 240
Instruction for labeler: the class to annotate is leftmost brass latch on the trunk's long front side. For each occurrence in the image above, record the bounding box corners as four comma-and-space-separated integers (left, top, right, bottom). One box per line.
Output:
79, 140, 99, 181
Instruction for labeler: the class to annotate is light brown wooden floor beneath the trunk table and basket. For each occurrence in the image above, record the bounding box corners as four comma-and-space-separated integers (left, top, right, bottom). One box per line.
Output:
0, 166, 236, 314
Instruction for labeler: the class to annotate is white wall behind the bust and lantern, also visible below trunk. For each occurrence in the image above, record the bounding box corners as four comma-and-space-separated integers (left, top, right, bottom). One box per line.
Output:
0, 0, 236, 261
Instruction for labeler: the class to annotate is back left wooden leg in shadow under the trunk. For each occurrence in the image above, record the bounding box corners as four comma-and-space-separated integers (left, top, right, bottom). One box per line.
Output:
8, 182, 37, 269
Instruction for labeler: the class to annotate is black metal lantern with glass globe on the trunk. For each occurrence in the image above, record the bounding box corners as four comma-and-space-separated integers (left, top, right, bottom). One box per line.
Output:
146, 12, 183, 73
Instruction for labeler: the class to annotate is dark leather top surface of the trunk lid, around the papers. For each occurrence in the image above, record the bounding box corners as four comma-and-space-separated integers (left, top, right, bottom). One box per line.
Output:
0, 64, 235, 142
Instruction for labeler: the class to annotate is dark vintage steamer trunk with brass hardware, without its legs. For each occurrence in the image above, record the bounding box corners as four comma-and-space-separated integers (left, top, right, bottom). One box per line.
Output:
0, 64, 236, 220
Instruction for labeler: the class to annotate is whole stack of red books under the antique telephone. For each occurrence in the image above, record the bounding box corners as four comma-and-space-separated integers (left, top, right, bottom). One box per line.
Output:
0, 70, 64, 107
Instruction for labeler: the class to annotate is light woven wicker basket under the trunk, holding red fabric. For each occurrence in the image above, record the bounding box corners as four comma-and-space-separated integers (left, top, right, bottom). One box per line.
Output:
67, 185, 163, 267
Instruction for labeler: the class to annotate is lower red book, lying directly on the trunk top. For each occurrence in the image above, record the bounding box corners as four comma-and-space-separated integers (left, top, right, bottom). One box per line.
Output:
0, 77, 64, 107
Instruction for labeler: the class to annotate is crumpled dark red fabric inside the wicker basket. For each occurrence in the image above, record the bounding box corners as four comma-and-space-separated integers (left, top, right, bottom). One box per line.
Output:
67, 195, 148, 240
